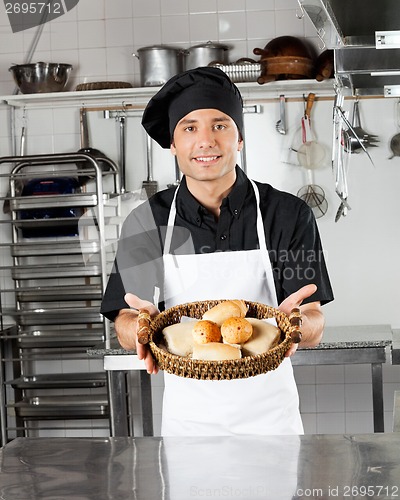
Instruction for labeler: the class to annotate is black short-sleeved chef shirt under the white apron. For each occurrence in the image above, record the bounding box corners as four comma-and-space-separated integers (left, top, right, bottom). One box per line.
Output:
101, 167, 333, 320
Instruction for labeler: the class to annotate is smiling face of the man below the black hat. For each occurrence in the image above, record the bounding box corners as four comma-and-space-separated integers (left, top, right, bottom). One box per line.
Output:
171, 109, 243, 187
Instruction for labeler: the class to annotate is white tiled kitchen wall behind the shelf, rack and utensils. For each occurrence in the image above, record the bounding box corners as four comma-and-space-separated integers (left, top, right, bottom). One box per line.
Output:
0, 0, 400, 433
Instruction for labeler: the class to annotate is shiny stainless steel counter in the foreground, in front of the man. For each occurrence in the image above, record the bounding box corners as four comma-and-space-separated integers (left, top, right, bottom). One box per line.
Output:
0, 433, 400, 500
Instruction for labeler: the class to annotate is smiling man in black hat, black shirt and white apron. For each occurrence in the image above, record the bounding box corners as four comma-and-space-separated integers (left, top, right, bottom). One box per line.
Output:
101, 67, 333, 436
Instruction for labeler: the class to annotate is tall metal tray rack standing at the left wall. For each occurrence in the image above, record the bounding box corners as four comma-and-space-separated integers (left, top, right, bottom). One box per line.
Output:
0, 153, 121, 444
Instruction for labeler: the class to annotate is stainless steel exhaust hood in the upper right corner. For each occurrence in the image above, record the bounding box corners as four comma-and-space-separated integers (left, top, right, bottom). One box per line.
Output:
298, 0, 400, 97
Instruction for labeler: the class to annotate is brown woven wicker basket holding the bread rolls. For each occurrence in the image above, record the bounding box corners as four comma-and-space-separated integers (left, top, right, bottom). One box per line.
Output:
137, 300, 301, 380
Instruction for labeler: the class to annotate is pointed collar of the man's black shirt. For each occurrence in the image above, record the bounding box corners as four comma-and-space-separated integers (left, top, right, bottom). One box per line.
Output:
176, 165, 249, 226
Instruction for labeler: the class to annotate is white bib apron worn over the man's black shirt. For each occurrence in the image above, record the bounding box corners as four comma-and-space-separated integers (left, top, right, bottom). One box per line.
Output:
161, 181, 303, 436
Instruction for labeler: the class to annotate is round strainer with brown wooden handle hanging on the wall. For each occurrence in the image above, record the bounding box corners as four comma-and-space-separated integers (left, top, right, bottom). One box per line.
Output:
297, 92, 325, 169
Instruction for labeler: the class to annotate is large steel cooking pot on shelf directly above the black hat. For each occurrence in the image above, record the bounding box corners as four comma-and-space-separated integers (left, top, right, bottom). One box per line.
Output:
132, 45, 184, 87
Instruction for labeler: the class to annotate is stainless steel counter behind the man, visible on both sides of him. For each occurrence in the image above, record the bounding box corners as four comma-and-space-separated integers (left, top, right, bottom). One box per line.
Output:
88, 325, 392, 436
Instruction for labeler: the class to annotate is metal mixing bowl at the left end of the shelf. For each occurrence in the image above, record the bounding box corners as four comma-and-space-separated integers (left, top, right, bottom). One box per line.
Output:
9, 62, 72, 94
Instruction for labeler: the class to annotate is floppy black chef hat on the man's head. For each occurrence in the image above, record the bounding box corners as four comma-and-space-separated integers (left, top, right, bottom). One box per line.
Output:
142, 66, 243, 149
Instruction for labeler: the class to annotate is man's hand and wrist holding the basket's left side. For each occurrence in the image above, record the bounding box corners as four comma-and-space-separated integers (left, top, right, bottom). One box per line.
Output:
114, 293, 159, 374
